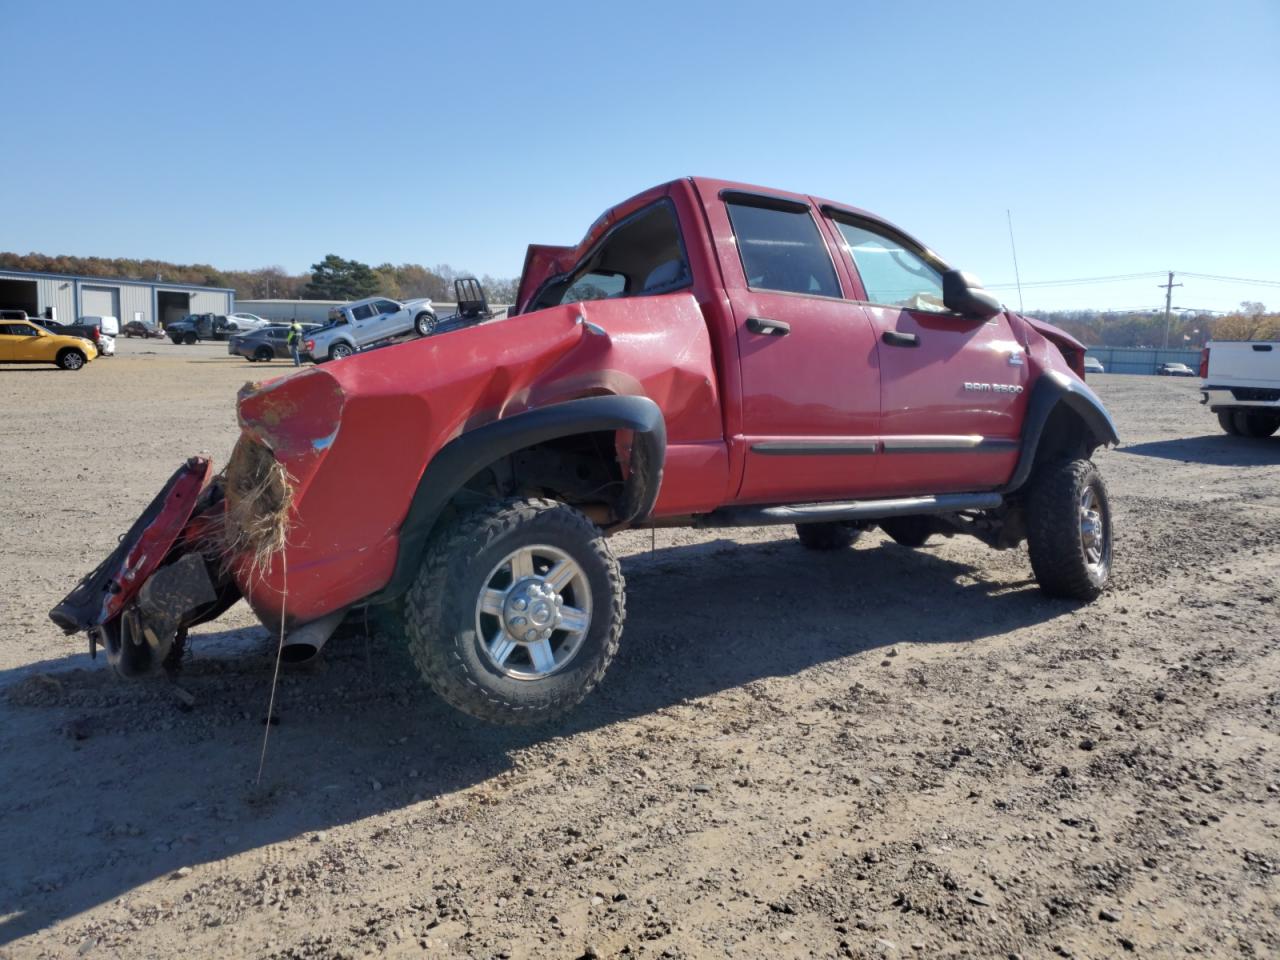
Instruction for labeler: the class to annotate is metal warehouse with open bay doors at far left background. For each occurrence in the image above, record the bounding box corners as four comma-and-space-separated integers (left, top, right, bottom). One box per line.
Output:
0, 270, 236, 325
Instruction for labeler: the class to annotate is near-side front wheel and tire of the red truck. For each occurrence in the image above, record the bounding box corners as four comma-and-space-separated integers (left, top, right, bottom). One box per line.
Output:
1027, 460, 1111, 600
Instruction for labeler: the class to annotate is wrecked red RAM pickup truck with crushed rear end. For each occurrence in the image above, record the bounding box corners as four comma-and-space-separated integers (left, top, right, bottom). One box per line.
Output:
51, 178, 1117, 723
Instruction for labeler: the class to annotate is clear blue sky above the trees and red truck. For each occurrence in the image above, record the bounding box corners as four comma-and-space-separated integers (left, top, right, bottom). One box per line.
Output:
0, 0, 1280, 308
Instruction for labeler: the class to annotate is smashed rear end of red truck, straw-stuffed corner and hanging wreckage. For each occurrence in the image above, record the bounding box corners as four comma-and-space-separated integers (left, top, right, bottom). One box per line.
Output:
49, 371, 349, 677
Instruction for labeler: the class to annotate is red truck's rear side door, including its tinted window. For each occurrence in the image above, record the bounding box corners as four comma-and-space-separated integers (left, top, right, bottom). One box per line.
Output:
703, 186, 879, 503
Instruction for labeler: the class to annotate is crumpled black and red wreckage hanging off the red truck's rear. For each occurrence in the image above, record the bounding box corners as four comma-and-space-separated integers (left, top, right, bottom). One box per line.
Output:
49, 457, 241, 677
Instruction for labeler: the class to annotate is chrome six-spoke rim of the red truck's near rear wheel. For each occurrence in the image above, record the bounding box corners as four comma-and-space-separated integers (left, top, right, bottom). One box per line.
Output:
476, 545, 591, 680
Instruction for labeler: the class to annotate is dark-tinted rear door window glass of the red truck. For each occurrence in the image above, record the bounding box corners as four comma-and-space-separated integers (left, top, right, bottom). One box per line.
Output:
724, 204, 841, 297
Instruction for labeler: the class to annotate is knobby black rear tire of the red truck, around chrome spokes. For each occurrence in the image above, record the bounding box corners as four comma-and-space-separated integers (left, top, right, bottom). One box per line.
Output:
404, 499, 626, 724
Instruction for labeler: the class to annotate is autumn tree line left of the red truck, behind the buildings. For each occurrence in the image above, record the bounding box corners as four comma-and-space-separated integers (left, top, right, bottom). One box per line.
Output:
0, 252, 518, 303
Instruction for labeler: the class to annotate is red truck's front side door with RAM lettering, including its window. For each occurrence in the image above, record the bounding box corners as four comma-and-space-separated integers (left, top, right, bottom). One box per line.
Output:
824, 207, 1028, 494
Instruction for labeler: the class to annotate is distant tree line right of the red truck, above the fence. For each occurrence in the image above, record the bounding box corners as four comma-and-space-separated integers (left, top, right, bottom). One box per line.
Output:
1028, 301, 1280, 349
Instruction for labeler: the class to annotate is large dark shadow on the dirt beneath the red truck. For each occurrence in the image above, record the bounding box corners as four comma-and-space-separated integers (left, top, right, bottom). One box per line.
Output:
0, 534, 1073, 943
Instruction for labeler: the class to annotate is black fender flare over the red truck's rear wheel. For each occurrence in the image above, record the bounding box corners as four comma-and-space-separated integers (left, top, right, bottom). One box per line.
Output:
370, 396, 667, 603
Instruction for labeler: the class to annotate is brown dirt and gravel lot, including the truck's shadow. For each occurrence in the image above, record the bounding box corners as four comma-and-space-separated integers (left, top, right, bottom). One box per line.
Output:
0, 340, 1280, 959
